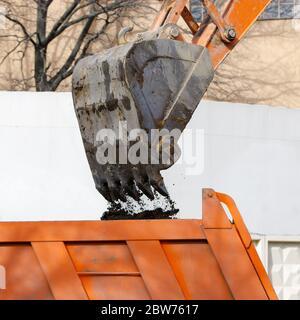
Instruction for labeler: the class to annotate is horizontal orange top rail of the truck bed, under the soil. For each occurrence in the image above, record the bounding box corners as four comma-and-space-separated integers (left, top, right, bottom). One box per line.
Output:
0, 220, 205, 243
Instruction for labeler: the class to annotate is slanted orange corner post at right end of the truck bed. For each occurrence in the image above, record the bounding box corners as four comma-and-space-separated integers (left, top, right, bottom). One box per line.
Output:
203, 190, 268, 300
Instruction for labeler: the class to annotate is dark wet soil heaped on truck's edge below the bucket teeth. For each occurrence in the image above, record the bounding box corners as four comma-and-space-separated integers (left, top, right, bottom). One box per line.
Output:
101, 208, 179, 220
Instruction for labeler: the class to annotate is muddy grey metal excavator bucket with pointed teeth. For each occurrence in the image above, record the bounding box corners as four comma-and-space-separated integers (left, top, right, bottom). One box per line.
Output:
73, 39, 213, 201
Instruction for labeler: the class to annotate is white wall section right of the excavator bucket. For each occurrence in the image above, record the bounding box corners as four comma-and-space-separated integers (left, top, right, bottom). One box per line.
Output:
173, 101, 300, 234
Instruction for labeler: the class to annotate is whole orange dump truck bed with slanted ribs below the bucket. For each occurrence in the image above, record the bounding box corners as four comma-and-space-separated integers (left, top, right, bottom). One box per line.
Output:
0, 189, 277, 300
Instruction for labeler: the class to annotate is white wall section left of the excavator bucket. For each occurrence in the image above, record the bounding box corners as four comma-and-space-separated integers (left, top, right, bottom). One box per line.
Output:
0, 92, 106, 221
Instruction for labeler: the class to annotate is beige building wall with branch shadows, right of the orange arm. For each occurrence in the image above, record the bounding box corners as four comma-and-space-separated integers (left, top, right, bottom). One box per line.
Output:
206, 20, 300, 108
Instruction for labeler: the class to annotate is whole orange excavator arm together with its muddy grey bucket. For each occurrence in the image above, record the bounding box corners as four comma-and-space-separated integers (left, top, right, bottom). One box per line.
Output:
72, 0, 270, 202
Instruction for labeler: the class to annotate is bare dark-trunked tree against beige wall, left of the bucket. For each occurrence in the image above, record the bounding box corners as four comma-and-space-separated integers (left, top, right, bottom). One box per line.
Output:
0, 0, 153, 91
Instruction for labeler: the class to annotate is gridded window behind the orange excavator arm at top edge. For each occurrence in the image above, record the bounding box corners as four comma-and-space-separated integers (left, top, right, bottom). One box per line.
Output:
190, 0, 300, 22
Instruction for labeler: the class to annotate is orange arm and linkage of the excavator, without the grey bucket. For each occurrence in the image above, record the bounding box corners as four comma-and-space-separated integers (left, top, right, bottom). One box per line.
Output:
151, 0, 271, 69
